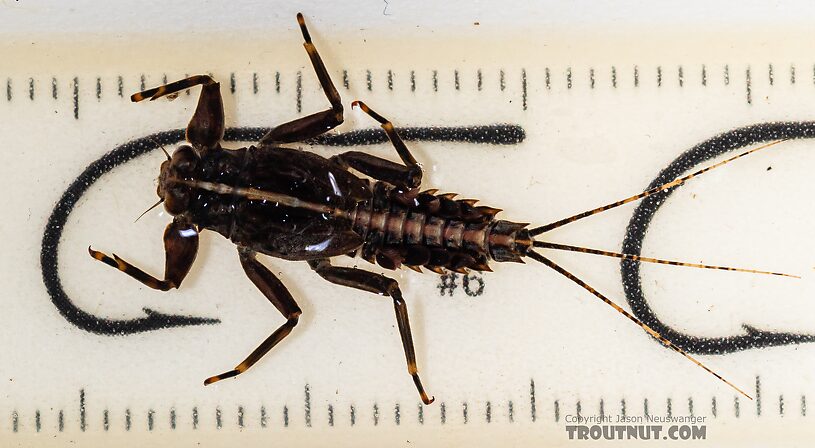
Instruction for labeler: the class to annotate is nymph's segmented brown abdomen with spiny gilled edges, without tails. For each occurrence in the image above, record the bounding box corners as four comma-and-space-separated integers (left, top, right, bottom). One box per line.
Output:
349, 182, 532, 273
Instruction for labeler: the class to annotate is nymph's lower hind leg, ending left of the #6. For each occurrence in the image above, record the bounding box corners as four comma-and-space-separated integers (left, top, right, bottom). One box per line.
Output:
308, 259, 435, 404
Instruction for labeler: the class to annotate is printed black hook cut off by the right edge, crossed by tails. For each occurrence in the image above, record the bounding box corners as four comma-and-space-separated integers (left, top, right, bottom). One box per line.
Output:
621, 121, 815, 354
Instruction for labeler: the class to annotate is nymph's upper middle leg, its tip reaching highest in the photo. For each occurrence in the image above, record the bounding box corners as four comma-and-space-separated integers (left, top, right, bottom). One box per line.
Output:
260, 13, 343, 145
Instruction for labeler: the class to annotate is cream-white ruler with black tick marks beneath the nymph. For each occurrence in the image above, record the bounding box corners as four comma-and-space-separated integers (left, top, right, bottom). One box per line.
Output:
0, 4, 815, 446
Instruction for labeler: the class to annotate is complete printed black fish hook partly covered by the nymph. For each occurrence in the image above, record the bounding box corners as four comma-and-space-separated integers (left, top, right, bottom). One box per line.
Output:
40, 124, 526, 335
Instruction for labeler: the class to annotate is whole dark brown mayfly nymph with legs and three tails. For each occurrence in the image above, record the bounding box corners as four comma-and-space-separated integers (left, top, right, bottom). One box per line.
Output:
89, 14, 792, 404
